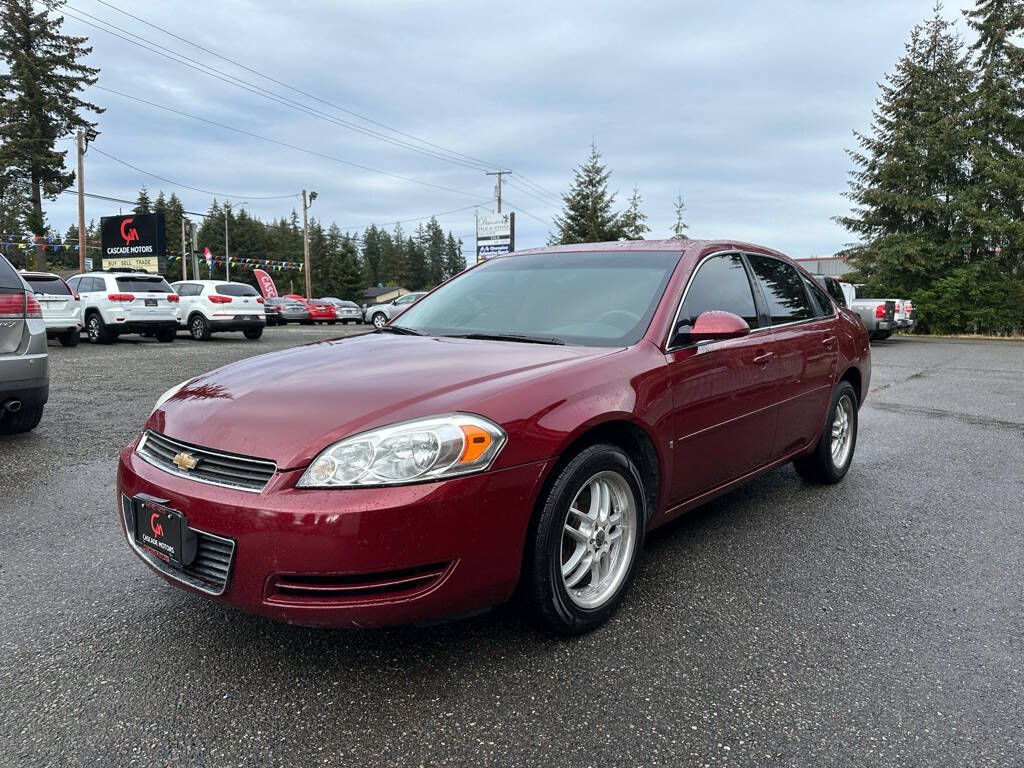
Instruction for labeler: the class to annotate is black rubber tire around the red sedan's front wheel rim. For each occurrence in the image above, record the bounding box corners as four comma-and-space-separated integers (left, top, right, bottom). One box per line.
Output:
520, 443, 648, 635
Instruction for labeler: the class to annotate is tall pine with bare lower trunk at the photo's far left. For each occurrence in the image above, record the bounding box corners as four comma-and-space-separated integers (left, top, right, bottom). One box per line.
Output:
0, 0, 102, 269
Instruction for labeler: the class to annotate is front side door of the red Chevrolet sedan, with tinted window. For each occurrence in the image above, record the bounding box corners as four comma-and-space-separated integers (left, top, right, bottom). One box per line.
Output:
667, 253, 776, 504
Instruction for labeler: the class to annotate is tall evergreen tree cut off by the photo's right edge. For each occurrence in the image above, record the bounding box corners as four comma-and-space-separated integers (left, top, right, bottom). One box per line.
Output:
964, 0, 1024, 273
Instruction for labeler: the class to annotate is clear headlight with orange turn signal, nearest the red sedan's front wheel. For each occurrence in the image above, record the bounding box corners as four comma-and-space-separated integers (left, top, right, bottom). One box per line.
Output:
297, 414, 506, 488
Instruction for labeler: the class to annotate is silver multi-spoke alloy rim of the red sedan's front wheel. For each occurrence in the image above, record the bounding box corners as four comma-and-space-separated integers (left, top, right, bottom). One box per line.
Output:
560, 471, 637, 608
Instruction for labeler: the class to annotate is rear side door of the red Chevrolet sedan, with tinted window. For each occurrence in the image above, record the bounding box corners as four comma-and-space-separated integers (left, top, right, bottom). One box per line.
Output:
748, 259, 839, 459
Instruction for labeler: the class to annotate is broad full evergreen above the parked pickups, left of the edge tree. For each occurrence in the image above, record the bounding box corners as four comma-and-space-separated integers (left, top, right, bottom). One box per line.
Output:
838, 5, 972, 296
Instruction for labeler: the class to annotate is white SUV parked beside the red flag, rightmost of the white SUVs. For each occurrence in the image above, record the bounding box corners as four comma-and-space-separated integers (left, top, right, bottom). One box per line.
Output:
172, 280, 266, 341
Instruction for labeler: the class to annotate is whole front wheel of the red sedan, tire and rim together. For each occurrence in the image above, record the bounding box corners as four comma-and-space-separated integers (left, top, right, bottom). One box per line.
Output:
523, 444, 647, 635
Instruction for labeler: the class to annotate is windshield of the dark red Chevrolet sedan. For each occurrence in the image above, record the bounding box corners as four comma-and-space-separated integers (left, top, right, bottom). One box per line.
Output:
396, 251, 680, 346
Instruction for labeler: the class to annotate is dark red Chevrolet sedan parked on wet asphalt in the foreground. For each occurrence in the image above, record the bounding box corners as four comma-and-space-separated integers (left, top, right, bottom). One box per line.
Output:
118, 241, 870, 633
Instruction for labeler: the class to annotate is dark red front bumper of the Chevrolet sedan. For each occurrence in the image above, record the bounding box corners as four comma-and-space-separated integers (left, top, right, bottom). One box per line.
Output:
118, 443, 549, 627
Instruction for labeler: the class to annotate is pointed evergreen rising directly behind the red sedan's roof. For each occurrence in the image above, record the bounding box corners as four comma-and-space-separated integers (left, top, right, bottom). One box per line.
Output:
549, 144, 626, 245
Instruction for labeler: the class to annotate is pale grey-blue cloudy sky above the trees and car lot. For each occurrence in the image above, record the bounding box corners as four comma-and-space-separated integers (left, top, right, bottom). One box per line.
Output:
39, 0, 965, 257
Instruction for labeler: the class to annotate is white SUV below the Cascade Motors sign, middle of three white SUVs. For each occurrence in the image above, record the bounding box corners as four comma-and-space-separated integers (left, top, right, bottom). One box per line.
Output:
68, 271, 180, 344
